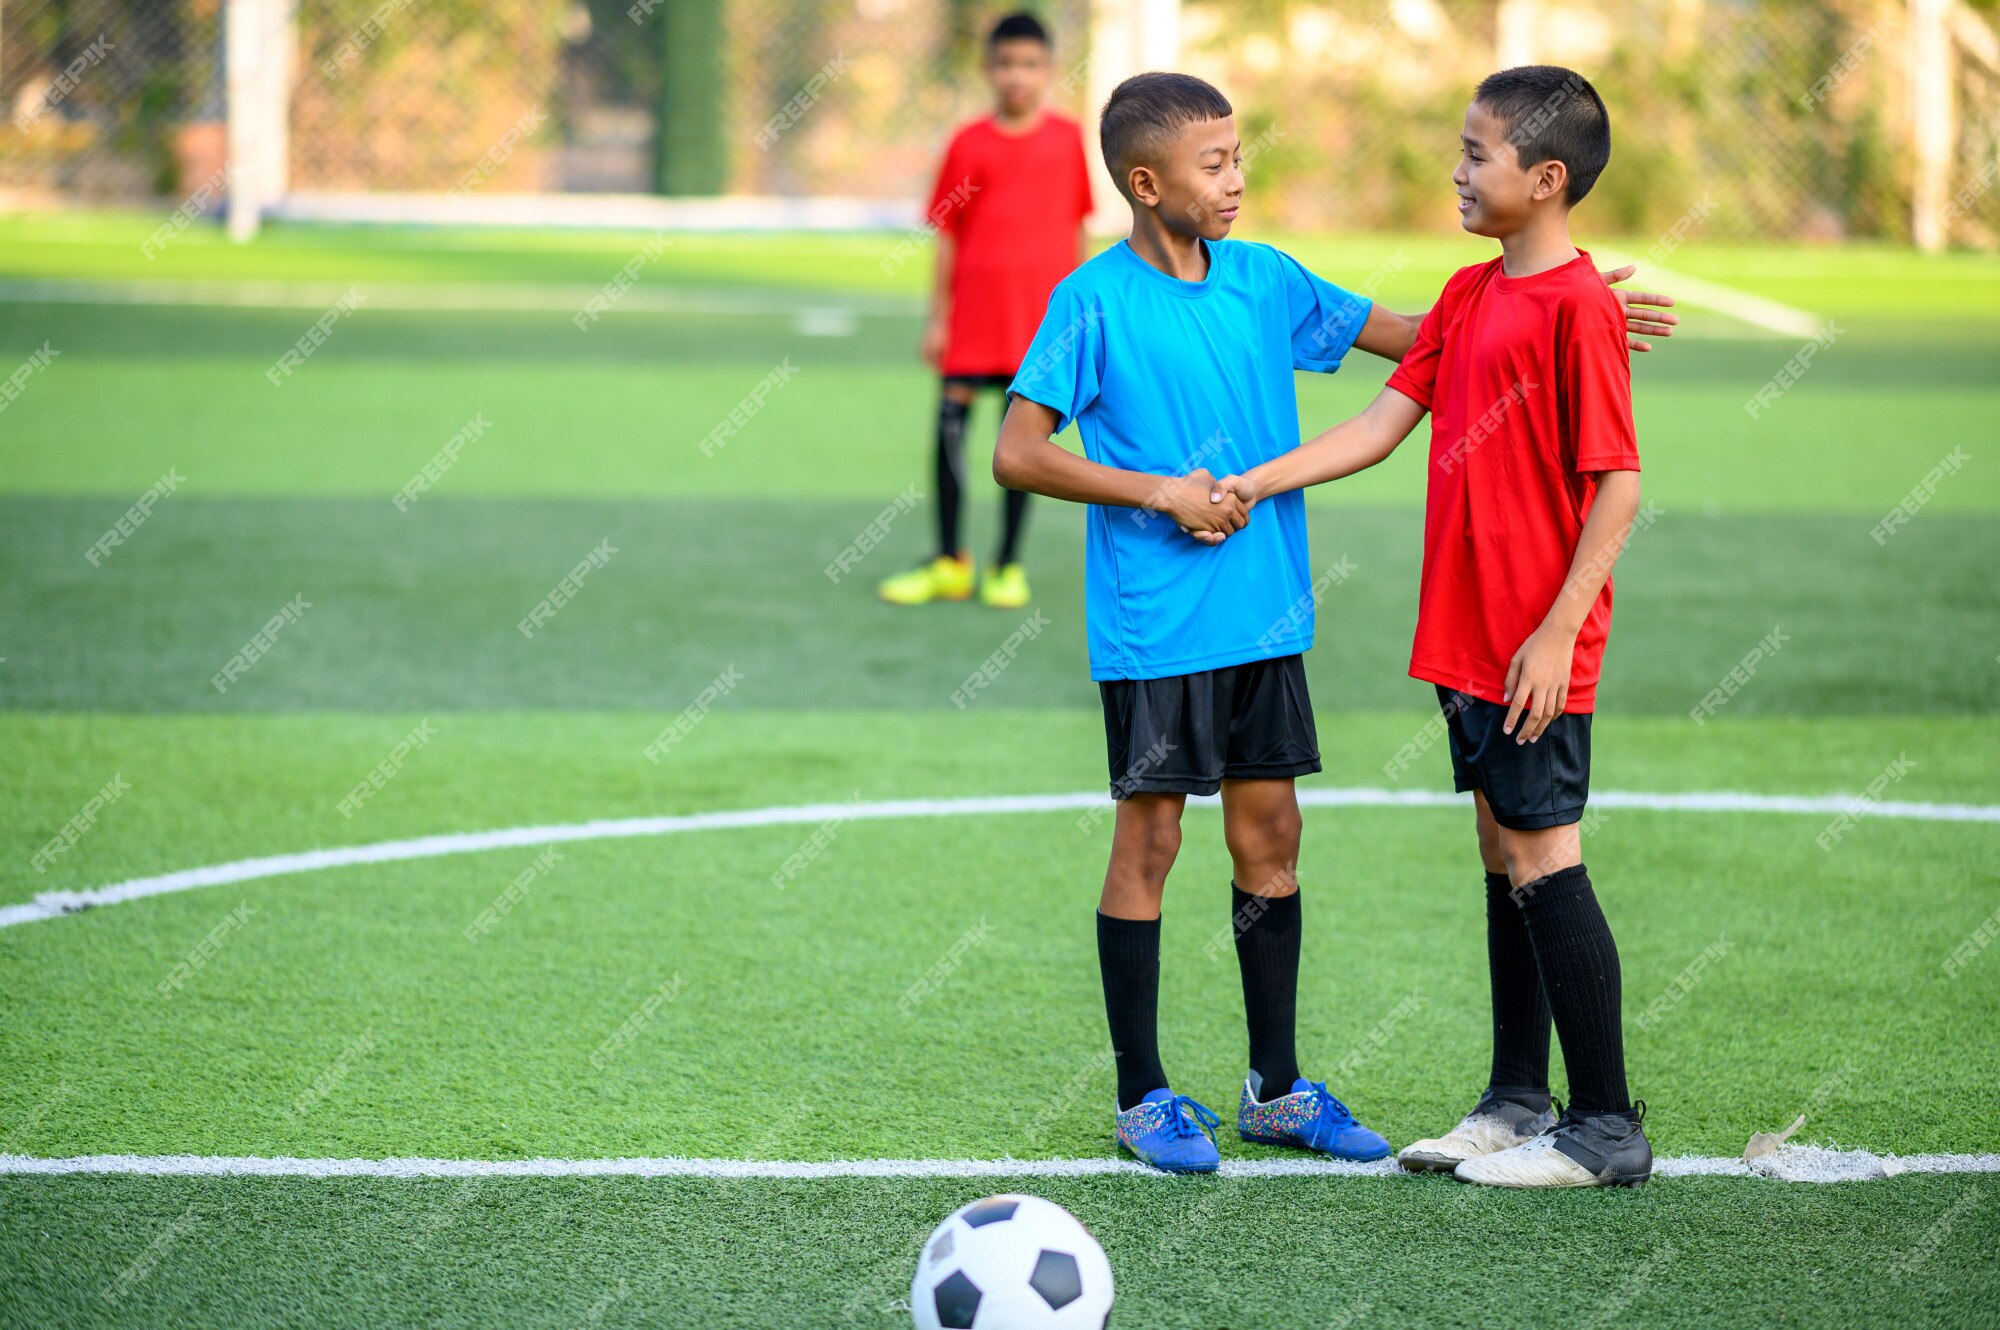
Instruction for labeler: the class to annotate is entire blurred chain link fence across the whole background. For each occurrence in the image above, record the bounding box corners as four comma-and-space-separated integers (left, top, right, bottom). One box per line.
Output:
0, 0, 2000, 246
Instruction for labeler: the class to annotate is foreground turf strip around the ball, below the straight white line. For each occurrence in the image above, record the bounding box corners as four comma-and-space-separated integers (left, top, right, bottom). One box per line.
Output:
0, 1178, 2000, 1330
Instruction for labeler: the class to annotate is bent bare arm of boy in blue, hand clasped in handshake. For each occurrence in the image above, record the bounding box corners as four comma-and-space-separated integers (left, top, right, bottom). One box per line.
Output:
994, 394, 1248, 544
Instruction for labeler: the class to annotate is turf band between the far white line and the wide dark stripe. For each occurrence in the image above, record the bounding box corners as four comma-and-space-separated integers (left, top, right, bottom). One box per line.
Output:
0, 304, 2000, 512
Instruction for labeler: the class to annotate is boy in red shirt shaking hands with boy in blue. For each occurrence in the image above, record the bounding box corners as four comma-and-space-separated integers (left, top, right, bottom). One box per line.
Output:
1214, 66, 1652, 1186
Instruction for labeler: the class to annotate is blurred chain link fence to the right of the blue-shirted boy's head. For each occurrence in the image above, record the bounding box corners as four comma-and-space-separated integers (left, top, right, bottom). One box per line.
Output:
1188, 0, 2000, 244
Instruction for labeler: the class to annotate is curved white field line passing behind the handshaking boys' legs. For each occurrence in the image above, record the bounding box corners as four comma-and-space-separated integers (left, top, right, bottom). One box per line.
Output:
0, 788, 2000, 928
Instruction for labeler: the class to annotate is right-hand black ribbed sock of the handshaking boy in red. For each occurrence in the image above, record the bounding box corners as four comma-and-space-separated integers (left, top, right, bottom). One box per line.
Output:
1520, 864, 1632, 1112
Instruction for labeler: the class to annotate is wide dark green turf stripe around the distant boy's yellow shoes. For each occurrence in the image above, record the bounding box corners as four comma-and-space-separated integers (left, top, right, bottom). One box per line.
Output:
0, 492, 2000, 716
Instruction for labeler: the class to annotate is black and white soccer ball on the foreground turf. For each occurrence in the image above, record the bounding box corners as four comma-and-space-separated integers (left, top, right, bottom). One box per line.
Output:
910, 1196, 1112, 1330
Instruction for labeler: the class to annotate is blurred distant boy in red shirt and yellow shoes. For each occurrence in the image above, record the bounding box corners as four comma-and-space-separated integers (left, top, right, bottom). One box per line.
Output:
878, 14, 1090, 610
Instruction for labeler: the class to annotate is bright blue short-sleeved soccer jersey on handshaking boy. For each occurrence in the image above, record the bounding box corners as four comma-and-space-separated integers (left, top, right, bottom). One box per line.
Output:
1008, 240, 1370, 680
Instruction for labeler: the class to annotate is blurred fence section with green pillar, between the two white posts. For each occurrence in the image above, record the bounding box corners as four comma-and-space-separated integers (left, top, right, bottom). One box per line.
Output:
290, 0, 1086, 198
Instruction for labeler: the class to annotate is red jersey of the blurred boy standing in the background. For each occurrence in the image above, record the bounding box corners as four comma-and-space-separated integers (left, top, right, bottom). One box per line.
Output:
926, 112, 1090, 376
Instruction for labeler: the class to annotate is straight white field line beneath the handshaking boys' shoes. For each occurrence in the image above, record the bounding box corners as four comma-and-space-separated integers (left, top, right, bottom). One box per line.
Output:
0, 1150, 2000, 1182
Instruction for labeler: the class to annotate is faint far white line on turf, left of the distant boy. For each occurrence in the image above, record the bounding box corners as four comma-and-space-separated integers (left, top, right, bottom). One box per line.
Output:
0, 278, 922, 316
